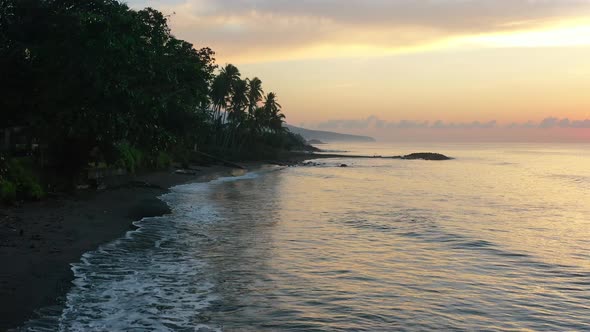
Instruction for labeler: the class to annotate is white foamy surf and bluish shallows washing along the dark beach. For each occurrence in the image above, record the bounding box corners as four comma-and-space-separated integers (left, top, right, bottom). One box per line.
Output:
23, 168, 279, 332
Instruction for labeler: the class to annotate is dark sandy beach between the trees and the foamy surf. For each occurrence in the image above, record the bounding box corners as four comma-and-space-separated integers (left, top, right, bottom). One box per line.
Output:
0, 166, 243, 331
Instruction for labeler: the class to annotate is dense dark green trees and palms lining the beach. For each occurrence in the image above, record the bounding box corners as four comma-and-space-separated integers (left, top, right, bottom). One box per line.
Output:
0, 0, 302, 198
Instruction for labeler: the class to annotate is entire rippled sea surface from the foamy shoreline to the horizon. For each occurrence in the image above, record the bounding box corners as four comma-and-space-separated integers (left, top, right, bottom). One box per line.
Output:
29, 144, 590, 331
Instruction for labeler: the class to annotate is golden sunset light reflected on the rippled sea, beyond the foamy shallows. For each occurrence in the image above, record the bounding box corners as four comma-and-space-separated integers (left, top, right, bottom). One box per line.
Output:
200, 145, 590, 330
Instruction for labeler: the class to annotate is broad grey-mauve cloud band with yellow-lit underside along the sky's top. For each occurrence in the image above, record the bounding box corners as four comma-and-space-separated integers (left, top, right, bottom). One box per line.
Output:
131, 0, 590, 60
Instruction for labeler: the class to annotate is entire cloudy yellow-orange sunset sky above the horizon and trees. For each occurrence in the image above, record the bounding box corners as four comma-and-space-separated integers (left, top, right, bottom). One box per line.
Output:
127, 0, 590, 142
